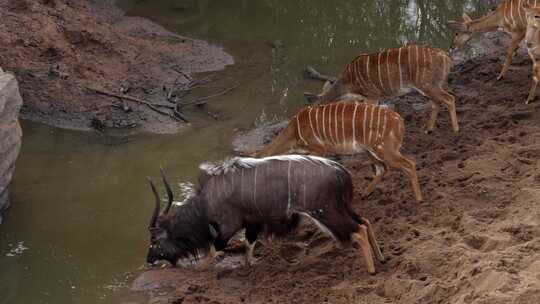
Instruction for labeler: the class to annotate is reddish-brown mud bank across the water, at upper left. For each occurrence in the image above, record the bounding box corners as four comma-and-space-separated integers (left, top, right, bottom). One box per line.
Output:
0, 0, 233, 132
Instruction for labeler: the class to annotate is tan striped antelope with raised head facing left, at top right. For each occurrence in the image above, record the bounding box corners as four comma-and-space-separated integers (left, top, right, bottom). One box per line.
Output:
448, 0, 540, 80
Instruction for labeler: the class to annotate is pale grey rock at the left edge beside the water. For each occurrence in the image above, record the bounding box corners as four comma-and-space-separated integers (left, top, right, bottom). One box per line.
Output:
0, 69, 22, 223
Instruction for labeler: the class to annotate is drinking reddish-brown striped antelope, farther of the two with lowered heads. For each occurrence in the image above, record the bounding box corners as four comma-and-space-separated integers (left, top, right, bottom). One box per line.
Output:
304, 45, 459, 132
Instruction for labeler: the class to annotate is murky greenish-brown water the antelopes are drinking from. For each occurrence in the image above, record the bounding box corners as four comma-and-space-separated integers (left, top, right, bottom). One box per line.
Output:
0, 0, 492, 304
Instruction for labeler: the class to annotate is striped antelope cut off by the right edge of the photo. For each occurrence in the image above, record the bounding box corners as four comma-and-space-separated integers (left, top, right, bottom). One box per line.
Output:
523, 5, 540, 104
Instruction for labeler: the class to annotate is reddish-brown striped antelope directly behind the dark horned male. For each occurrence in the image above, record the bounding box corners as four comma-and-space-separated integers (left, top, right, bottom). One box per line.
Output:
255, 101, 422, 202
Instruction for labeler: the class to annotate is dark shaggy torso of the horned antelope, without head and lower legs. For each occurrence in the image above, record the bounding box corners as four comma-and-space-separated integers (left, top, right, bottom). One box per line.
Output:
198, 155, 360, 243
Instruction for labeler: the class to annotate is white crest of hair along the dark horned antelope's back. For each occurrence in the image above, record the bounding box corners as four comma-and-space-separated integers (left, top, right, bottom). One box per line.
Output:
199, 155, 343, 176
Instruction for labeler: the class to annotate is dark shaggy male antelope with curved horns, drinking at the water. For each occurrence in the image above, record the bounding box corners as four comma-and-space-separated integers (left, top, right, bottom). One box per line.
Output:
147, 155, 384, 274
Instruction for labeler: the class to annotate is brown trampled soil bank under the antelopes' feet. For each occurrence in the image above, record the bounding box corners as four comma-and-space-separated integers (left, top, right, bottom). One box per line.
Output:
124, 34, 540, 304
